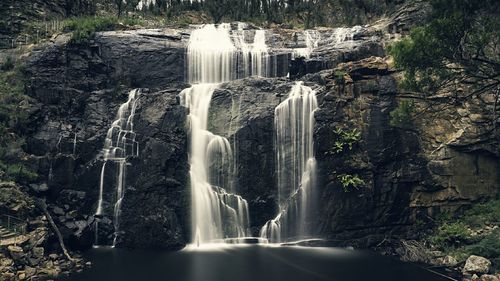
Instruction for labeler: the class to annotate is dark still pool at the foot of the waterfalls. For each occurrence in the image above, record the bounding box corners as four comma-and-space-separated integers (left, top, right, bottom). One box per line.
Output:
63, 245, 447, 281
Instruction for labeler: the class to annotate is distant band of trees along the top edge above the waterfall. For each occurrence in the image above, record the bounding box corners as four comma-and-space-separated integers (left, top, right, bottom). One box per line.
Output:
125, 0, 402, 28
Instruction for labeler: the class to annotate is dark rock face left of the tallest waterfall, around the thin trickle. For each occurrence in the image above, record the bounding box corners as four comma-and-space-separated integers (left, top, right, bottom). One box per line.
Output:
22, 31, 188, 248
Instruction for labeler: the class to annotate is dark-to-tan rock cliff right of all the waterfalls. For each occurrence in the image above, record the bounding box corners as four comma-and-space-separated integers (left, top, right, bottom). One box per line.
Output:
310, 57, 499, 246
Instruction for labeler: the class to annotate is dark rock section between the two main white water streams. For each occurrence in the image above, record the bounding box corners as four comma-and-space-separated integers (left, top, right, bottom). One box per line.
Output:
209, 78, 292, 232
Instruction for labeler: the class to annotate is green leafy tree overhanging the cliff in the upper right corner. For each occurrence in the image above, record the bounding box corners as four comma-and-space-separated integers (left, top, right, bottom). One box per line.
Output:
389, 0, 500, 98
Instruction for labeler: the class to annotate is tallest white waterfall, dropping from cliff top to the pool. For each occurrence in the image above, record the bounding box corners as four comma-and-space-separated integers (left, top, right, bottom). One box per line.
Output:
180, 24, 262, 246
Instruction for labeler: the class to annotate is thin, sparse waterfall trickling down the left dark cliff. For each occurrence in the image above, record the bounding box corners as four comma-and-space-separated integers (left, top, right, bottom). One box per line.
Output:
95, 89, 140, 245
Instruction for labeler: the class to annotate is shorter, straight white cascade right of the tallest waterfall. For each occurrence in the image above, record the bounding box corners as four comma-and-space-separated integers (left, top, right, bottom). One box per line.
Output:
260, 82, 318, 243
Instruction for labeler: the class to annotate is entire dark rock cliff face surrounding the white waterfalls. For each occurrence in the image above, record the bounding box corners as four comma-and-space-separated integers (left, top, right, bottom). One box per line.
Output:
22, 18, 500, 249
